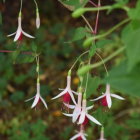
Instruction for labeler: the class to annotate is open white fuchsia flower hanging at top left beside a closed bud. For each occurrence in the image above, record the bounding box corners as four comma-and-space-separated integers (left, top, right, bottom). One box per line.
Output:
8, 13, 34, 42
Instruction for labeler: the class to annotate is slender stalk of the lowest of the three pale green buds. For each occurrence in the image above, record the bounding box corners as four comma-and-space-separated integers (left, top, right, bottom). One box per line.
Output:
90, 47, 125, 69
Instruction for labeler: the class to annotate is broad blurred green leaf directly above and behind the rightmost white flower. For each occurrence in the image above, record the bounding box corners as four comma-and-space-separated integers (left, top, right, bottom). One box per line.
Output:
105, 62, 140, 96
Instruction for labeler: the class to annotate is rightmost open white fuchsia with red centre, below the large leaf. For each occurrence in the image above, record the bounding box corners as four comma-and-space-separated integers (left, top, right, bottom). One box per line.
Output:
91, 84, 125, 108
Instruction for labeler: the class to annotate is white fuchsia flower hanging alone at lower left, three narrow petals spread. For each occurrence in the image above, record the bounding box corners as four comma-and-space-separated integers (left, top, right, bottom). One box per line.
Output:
25, 83, 48, 109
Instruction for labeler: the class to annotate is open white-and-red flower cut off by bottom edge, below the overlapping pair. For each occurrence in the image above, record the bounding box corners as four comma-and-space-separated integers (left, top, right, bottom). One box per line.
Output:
70, 125, 87, 140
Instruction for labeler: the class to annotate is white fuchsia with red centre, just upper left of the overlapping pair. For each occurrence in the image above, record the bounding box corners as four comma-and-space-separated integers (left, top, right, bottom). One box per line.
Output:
52, 76, 76, 104
